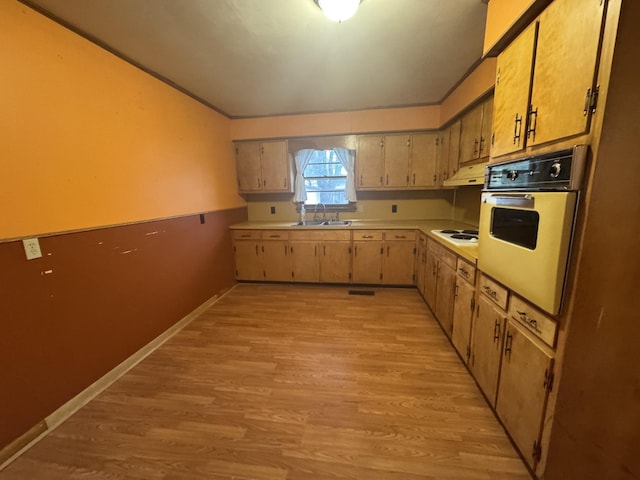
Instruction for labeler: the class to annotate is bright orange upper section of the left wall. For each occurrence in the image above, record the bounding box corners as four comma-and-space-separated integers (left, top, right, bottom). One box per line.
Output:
0, 0, 245, 239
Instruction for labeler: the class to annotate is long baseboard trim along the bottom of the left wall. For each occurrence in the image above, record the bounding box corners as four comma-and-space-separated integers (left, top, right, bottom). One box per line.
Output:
0, 284, 237, 472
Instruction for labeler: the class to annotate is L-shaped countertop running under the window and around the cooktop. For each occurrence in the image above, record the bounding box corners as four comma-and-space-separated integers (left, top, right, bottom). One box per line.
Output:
229, 220, 478, 263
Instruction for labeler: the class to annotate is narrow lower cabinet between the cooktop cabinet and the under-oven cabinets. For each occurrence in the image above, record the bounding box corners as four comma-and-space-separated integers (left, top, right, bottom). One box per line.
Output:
451, 258, 476, 363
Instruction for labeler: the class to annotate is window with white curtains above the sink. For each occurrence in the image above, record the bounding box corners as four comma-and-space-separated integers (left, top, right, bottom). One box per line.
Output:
294, 148, 356, 208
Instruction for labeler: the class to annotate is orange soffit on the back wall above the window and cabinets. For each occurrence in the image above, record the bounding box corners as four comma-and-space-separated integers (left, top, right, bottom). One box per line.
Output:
231, 105, 440, 140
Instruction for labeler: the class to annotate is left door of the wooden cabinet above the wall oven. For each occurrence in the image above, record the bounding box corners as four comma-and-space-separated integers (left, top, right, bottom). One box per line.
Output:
491, 22, 538, 157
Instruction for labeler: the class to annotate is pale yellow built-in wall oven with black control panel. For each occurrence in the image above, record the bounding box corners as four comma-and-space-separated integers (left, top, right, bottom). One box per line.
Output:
478, 145, 587, 315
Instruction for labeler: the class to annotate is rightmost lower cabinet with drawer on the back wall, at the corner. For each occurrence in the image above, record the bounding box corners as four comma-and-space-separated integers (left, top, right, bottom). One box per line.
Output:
382, 230, 416, 285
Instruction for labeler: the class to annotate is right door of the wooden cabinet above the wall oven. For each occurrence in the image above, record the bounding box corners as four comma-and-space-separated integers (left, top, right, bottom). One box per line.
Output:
527, 0, 605, 145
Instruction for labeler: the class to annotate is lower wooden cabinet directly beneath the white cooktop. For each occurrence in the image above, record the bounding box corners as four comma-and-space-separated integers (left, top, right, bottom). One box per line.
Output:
425, 239, 457, 337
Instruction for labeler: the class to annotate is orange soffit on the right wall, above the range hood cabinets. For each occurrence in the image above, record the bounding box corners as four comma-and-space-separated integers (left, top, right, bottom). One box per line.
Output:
440, 58, 497, 125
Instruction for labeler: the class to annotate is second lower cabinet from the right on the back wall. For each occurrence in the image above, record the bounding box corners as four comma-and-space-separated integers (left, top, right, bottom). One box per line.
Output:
353, 230, 384, 284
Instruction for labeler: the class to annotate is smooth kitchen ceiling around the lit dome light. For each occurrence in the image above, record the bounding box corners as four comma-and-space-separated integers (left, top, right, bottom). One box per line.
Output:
24, 0, 487, 118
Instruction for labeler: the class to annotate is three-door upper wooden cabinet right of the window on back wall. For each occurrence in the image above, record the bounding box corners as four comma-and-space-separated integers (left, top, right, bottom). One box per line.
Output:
356, 132, 438, 190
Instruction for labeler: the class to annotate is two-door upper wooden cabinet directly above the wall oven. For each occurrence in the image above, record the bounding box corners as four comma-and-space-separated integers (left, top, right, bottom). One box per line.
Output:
492, 0, 605, 157
